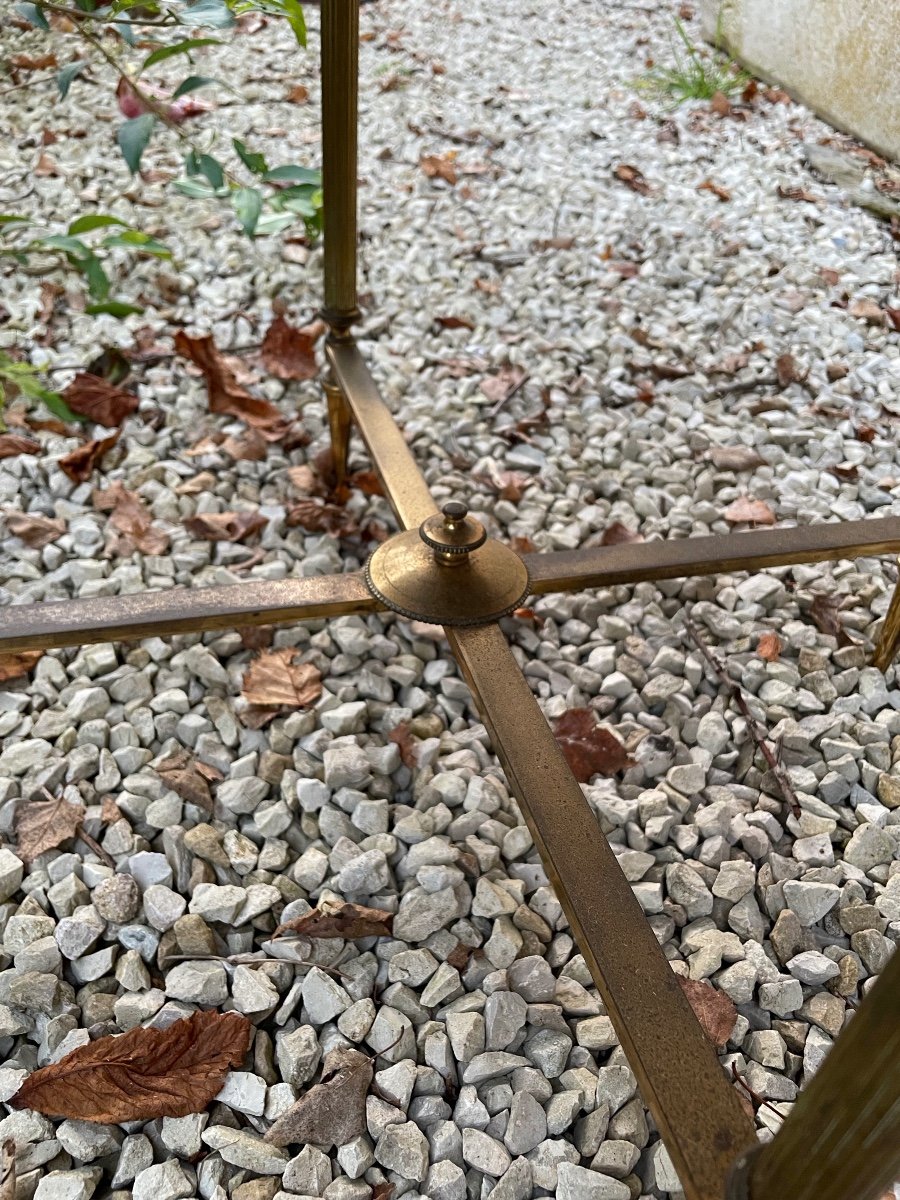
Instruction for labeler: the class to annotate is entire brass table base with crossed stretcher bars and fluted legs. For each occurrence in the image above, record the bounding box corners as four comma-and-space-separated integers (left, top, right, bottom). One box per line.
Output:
0, 0, 900, 1200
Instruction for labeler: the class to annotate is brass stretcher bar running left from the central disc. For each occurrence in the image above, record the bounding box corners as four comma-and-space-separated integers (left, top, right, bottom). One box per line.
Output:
0, 572, 384, 653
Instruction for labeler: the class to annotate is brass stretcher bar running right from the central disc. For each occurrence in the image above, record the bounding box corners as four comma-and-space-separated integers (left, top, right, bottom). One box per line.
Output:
522, 517, 900, 595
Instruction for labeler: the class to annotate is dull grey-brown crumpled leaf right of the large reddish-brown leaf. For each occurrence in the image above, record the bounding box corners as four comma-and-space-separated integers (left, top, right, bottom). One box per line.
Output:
265, 1046, 374, 1150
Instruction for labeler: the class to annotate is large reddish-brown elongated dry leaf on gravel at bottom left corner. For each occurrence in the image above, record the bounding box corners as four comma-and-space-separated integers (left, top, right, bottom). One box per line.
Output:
7, 1013, 253, 1124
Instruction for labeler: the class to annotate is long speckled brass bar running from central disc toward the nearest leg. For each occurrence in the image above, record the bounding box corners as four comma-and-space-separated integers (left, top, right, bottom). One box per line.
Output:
445, 625, 758, 1200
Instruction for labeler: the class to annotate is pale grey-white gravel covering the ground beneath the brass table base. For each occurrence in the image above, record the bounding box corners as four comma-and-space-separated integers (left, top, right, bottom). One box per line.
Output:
0, 0, 900, 1200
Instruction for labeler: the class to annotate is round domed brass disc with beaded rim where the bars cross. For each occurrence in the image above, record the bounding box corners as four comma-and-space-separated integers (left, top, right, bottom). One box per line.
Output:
366, 516, 529, 625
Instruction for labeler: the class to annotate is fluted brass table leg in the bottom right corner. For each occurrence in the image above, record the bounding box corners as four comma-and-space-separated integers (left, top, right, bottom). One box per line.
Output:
749, 953, 900, 1200
